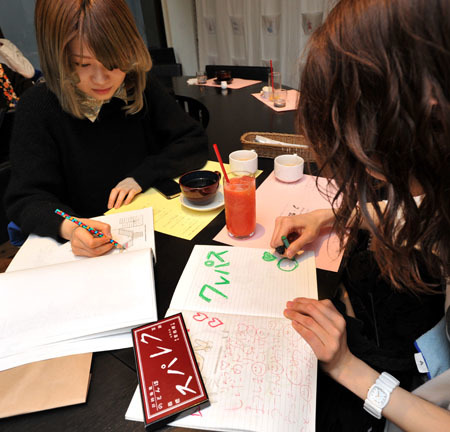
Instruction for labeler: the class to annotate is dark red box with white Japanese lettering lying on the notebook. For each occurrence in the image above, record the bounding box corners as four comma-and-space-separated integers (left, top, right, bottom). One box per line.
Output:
132, 313, 210, 431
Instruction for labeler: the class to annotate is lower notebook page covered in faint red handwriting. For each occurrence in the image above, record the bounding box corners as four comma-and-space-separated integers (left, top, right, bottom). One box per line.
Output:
168, 310, 317, 432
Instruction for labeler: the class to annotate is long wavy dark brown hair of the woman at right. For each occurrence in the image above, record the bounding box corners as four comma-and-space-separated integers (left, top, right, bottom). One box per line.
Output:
298, 0, 450, 292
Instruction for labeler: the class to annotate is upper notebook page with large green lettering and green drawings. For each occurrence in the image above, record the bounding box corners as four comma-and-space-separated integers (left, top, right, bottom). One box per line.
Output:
170, 245, 317, 318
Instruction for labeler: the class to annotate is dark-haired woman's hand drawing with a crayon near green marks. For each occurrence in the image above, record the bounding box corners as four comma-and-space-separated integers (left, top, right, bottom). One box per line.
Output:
270, 209, 334, 258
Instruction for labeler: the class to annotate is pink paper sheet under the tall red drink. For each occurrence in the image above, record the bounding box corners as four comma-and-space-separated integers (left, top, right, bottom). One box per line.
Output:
214, 172, 343, 271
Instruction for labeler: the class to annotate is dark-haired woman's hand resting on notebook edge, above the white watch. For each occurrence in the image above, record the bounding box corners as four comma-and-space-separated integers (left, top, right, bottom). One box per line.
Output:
284, 298, 353, 379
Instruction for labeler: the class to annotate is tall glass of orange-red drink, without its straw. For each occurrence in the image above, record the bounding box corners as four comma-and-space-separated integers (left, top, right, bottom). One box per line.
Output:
223, 172, 256, 238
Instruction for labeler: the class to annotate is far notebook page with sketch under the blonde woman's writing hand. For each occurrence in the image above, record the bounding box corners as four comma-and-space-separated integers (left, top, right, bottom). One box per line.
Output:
8, 207, 156, 272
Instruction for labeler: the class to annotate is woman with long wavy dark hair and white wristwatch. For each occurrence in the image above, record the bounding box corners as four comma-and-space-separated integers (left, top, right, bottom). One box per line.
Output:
272, 0, 450, 431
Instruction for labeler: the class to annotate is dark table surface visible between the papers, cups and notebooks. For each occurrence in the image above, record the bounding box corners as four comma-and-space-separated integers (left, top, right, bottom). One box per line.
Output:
0, 77, 339, 432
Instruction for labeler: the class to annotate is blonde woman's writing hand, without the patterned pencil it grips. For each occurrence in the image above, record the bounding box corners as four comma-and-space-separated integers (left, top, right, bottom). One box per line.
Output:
60, 219, 114, 257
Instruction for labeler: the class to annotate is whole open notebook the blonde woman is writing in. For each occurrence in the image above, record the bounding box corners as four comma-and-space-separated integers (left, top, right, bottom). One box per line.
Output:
0, 208, 157, 371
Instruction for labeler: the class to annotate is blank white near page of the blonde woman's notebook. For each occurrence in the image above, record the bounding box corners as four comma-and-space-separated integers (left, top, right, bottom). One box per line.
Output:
0, 249, 157, 370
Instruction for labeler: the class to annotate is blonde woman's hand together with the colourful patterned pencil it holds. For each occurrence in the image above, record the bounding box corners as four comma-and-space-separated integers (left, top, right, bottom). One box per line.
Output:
55, 209, 123, 257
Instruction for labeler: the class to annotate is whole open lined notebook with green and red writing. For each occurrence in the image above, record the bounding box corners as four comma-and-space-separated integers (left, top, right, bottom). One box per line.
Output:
125, 245, 317, 432
